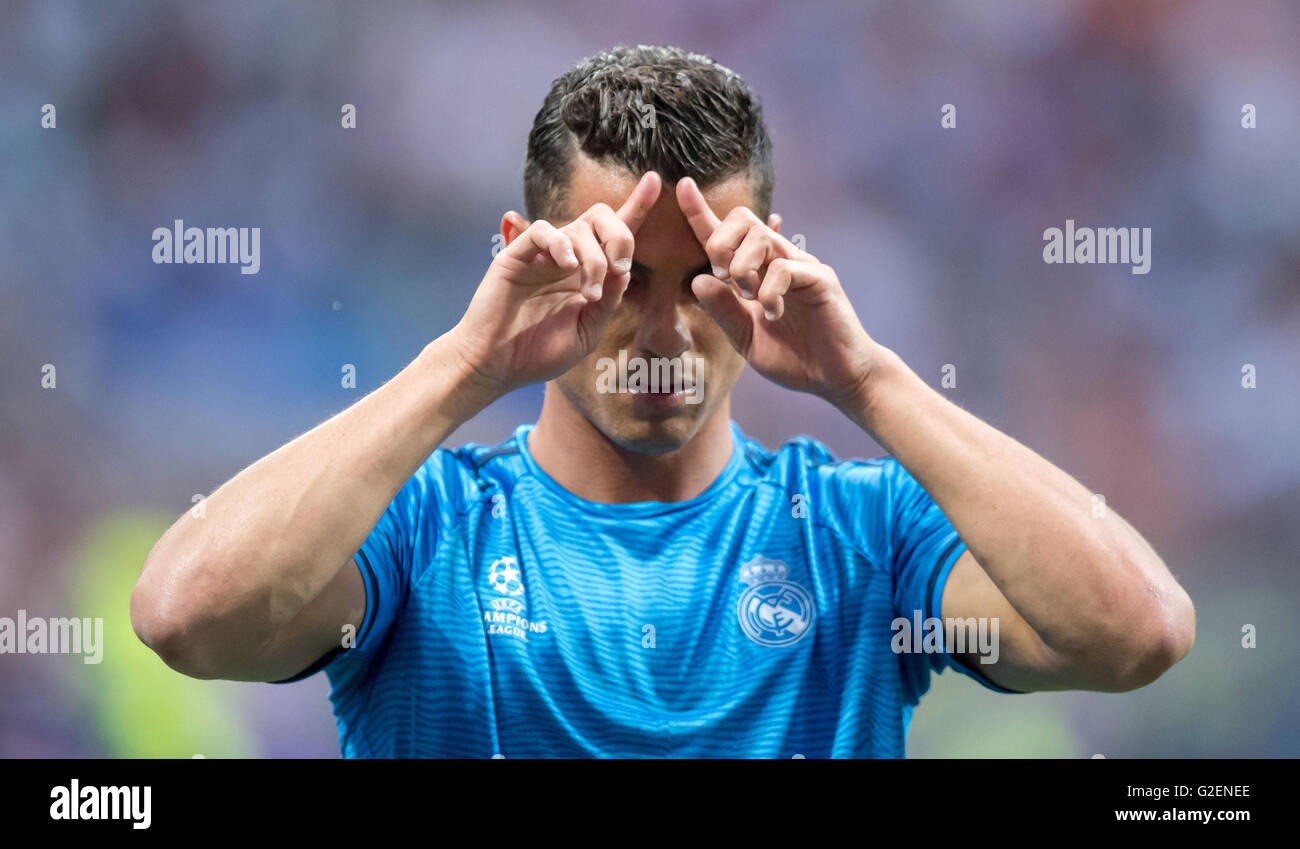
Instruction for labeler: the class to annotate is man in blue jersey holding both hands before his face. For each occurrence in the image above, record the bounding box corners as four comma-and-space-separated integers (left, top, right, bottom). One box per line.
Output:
131, 47, 1195, 758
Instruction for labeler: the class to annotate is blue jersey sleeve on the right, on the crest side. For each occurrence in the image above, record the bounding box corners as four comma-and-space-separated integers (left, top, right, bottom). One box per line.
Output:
887, 460, 1017, 698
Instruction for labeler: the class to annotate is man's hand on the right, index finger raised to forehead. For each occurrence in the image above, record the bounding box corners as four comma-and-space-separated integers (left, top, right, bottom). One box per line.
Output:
677, 178, 879, 412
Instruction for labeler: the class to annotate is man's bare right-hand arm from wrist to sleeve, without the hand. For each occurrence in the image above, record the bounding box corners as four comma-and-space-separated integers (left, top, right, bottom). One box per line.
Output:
842, 346, 1195, 692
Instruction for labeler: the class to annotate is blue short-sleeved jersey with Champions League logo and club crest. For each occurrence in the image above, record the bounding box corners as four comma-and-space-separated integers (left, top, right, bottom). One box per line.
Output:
282, 423, 1005, 758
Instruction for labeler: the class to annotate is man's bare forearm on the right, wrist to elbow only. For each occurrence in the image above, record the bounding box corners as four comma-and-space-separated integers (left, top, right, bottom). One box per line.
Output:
849, 348, 1191, 662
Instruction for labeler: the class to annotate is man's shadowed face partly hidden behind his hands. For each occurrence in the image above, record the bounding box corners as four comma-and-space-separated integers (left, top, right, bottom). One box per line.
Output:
553, 156, 754, 454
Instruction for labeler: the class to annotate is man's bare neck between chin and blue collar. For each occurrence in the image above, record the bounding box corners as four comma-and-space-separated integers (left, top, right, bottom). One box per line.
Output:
528, 384, 733, 504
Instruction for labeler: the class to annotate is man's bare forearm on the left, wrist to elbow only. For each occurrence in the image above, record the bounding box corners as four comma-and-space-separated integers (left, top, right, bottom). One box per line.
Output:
133, 335, 491, 654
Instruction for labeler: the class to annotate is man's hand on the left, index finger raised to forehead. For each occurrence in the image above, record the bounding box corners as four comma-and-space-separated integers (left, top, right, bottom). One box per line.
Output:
451, 172, 663, 393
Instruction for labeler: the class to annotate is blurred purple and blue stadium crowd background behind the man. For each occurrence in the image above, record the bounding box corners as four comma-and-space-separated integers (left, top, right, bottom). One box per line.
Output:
0, 0, 1300, 757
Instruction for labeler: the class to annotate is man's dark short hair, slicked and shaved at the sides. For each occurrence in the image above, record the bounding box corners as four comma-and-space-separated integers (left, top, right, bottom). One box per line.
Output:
524, 46, 774, 220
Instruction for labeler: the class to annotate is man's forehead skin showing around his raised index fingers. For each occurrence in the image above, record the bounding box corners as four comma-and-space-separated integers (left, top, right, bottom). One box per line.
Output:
567, 153, 754, 263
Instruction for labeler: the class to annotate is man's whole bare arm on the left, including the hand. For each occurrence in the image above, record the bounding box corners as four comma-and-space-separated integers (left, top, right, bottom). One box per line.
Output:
131, 172, 662, 681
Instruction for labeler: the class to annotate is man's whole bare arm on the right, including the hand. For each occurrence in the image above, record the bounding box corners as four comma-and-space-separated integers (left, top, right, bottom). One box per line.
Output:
677, 178, 1195, 690
